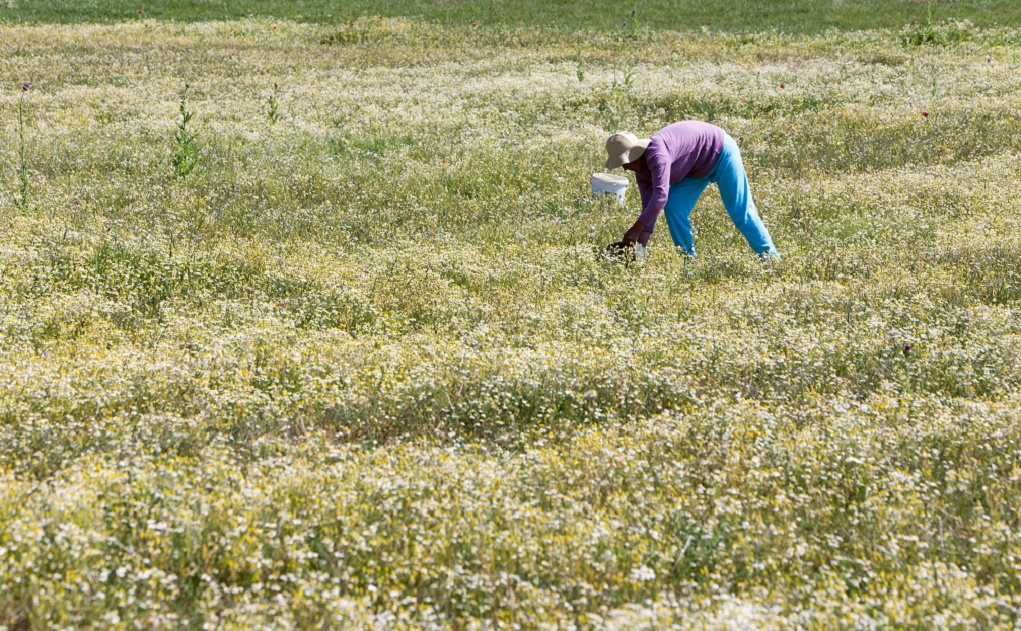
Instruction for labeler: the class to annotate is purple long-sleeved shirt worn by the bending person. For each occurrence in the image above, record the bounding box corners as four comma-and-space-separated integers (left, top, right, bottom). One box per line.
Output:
627, 120, 723, 245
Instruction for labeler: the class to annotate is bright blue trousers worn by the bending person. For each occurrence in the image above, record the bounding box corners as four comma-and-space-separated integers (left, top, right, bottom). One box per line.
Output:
663, 134, 780, 258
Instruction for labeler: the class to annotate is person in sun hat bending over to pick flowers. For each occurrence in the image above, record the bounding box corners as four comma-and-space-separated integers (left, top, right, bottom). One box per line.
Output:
606, 120, 780, 258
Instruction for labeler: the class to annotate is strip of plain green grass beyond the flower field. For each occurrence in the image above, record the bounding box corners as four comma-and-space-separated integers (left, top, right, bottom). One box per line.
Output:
0, 0, 1021, 33
